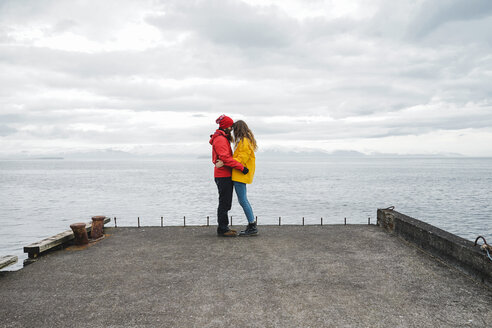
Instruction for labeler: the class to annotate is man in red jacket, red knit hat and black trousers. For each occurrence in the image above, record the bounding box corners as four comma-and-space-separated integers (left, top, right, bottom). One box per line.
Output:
210, 115, 249, 237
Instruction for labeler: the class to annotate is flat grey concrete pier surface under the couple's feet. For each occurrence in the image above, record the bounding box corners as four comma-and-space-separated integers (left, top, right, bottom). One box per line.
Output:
0, 225, 492, 327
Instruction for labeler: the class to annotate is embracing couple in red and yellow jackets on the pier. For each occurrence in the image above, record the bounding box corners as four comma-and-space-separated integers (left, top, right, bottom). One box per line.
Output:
210, 115, 258, 237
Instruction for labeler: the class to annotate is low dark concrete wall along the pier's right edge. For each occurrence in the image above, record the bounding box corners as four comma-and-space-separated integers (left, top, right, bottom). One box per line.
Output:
377, 209, 492, 287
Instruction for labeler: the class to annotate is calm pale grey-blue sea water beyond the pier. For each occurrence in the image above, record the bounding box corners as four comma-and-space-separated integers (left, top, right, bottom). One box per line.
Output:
0, 156, 492, 270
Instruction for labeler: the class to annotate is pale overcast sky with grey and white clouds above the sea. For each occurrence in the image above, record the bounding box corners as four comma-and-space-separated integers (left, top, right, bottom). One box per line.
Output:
0, 0, 492, 157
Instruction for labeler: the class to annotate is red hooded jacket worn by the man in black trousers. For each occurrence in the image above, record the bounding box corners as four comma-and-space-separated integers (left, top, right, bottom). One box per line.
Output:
210, 130, 244, 178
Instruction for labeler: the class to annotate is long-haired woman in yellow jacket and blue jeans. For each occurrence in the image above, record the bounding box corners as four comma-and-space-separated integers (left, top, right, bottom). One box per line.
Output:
217, 120, 258, 236
